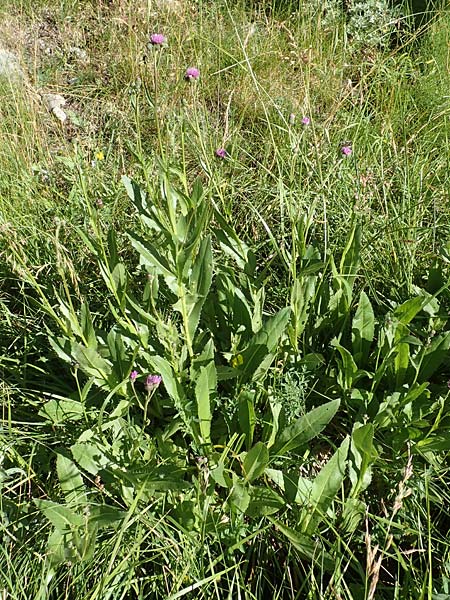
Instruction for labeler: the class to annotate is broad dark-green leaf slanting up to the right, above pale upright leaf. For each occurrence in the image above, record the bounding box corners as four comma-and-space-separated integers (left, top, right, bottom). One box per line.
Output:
272, 400, 340, 456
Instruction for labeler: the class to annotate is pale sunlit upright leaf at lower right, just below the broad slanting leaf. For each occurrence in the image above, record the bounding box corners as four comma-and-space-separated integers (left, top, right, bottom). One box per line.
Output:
301, 437, 350, 535
